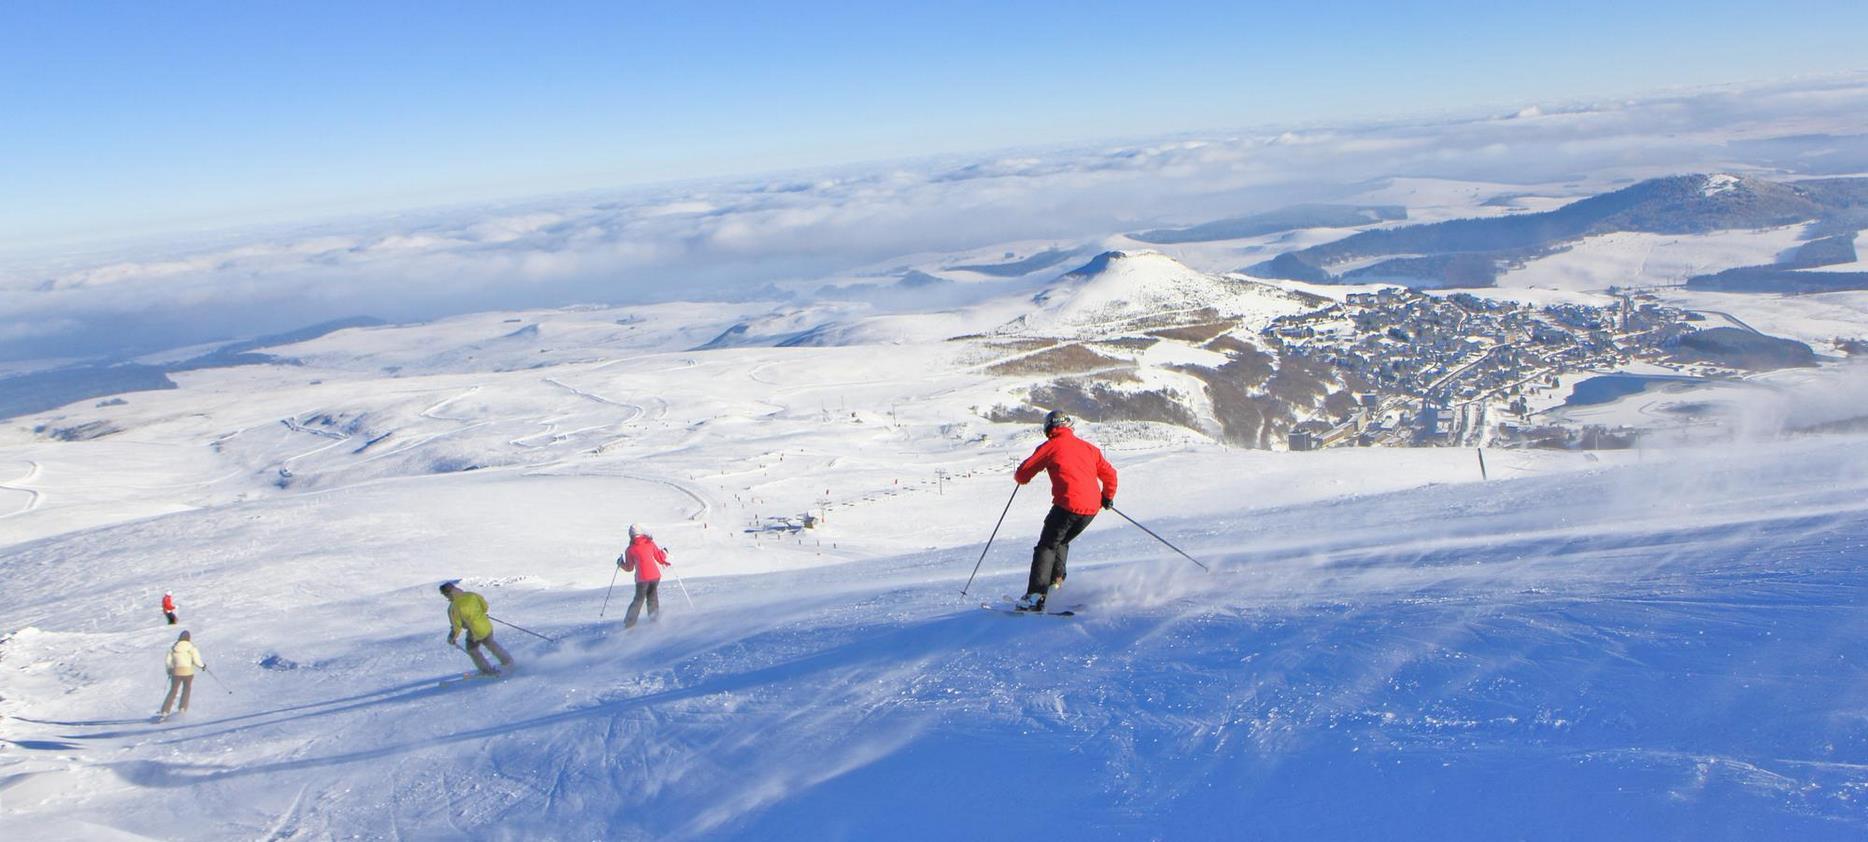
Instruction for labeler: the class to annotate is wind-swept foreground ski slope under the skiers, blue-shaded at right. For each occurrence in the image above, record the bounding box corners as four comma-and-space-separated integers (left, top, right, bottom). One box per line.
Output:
0, 429, 1868, 838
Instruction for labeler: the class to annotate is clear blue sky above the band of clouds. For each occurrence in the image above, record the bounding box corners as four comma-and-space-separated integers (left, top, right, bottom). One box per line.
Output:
0, 0, 1868, 250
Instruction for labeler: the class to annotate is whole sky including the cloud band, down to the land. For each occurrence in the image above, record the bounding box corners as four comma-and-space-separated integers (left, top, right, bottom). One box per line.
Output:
0, 2, 1868, 360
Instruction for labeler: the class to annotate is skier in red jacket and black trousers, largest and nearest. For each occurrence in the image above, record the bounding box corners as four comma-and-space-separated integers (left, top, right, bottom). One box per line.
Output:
1012, 409, 1115, 610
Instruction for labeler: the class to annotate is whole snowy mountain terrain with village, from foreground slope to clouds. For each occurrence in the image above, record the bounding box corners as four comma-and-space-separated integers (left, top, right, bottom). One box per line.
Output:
0, 163, 1868, 838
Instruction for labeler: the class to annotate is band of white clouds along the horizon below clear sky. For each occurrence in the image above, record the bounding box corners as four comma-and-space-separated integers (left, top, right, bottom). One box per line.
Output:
0, 77, 1868, 358
